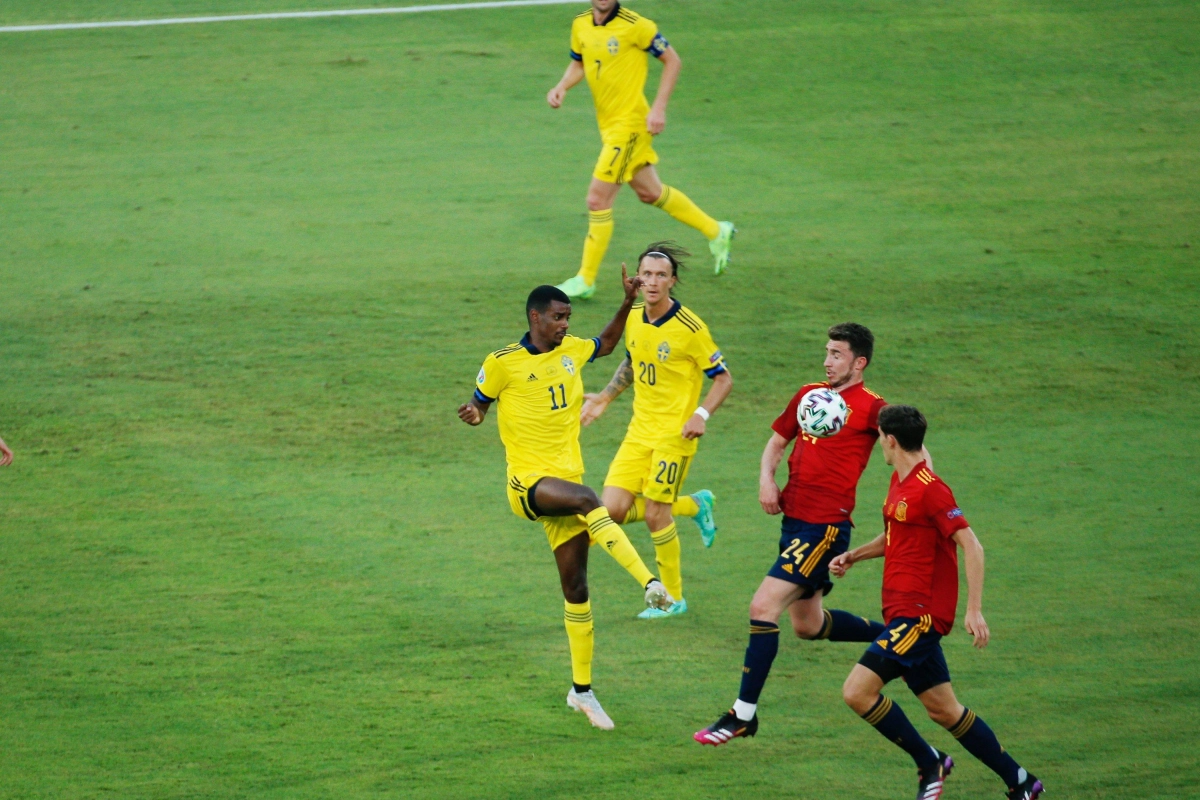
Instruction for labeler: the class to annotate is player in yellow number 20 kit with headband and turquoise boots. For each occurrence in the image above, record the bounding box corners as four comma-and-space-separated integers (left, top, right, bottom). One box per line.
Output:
582, 242, 733, 619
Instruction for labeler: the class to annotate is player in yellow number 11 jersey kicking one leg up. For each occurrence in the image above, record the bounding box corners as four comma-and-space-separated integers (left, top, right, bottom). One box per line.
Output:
458, 272, 674, 730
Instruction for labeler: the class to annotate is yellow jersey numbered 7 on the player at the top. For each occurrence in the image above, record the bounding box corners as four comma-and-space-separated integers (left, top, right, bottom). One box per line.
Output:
571, 2, 670, 133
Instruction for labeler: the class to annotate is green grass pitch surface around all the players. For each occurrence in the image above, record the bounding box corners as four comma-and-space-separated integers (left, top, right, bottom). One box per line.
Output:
0, 0, 1200, 800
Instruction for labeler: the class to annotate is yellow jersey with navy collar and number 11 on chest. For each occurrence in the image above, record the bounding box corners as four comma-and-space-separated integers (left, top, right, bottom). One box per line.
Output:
475, 333, 600, 477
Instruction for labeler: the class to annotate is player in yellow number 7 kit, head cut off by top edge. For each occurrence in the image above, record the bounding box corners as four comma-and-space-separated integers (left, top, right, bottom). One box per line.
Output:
546, 0, 734, 300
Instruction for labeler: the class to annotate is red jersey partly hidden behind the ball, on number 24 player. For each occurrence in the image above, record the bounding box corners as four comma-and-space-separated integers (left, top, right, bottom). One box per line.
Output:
770, 383, 887, 524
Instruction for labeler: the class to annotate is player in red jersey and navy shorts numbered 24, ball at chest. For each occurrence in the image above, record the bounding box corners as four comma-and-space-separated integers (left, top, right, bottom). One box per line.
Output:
692, 323, 916, 745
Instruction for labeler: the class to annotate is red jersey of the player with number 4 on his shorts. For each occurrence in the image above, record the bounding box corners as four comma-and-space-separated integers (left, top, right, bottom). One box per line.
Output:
883, 461, 967, 636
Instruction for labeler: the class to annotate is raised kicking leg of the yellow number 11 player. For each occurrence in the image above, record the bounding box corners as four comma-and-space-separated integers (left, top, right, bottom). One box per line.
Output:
529, 477, 674, 608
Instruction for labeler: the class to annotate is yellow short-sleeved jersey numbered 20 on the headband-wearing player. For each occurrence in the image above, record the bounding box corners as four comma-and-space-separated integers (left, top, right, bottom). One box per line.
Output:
625, 300, 725, 456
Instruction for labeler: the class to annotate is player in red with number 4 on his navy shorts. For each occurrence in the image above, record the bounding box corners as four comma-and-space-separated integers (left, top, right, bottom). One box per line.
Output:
829, 405, 1043, 800
